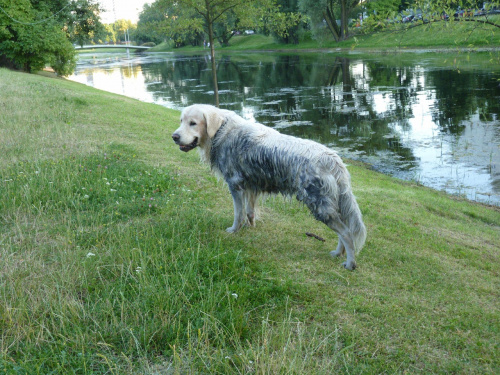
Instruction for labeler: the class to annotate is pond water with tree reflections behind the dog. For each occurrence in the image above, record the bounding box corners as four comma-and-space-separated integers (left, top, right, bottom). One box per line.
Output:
71, 54, 500, 204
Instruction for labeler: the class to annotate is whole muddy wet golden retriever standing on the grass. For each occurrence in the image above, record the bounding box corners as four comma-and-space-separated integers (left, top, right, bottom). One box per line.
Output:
172, 104, 366, 270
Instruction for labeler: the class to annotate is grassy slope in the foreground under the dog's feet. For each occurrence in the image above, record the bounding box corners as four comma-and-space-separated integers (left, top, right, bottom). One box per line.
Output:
0, 69, 500, 374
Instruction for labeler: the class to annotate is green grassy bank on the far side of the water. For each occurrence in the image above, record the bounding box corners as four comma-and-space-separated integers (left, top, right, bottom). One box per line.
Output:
150, 16, 500, 52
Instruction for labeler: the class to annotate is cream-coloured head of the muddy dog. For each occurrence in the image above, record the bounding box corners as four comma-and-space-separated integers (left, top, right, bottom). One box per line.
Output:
172, 104, 224, 152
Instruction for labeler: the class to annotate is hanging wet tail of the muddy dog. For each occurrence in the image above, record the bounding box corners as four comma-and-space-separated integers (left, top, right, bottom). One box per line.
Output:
339, 181, 366, 253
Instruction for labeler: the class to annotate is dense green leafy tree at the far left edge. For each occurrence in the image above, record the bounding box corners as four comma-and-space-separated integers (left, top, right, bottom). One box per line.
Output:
0, 0, 105, 75
